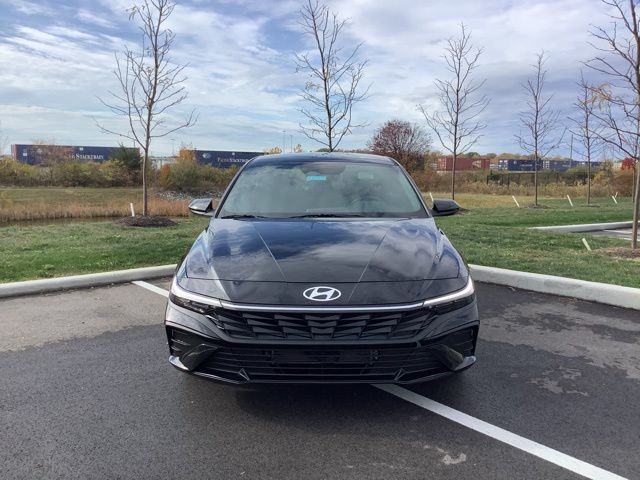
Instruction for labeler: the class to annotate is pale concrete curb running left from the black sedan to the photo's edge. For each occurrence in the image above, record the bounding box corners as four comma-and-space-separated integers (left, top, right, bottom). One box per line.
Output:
0, 265, 176, 298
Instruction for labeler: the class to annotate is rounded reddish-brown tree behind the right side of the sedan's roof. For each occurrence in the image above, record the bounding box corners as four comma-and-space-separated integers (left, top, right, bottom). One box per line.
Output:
367, 120, 430, 172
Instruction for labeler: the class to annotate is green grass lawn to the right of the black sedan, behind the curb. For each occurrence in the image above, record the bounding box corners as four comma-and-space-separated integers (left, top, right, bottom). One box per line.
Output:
436, 195, 640, 287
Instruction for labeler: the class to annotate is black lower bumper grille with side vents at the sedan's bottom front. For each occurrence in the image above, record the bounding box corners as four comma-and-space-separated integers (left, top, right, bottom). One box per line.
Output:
169, 327, 477, 383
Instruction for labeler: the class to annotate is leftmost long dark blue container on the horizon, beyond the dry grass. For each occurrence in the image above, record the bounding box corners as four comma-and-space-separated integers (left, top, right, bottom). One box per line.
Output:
11, 144, 138, 165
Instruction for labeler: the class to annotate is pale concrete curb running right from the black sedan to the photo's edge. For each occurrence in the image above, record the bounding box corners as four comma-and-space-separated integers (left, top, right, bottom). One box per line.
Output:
469, 265, 640, 310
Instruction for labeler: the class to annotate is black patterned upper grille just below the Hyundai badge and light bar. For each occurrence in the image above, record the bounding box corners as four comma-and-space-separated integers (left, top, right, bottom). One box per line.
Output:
208, 308, 434, 341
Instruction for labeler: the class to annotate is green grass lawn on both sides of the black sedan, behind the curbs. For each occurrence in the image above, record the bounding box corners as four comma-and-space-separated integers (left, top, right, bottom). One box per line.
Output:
0, 194, 640, 287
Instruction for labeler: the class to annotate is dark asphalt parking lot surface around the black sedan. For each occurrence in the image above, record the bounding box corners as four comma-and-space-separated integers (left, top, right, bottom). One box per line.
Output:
0, 281, 640, 479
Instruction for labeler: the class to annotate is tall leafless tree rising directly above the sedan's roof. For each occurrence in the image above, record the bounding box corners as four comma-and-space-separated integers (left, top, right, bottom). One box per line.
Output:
296, 0, 369, 152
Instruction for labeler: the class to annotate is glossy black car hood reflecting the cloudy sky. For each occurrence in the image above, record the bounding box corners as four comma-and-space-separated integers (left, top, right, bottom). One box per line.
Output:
185, 218, 466, 284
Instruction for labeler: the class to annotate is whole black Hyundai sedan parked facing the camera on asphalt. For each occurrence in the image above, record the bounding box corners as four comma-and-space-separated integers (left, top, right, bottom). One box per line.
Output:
165, 153, 479, 383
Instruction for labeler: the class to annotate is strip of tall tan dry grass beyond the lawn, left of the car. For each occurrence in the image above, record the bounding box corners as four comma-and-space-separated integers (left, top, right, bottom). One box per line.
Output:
0, 189, 189, 224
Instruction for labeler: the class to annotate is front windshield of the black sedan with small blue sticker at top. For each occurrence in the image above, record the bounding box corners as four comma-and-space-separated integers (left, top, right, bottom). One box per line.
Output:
218, 161, 428, 218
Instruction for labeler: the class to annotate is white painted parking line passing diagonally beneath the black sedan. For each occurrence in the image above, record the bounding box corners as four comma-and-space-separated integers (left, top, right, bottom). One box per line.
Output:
132, 281, 627, 480
